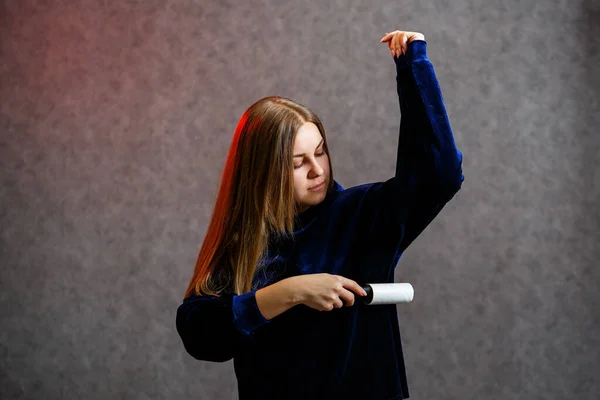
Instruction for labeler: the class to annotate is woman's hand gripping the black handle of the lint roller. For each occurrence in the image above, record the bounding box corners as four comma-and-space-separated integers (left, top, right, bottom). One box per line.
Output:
288, 273, 367, 311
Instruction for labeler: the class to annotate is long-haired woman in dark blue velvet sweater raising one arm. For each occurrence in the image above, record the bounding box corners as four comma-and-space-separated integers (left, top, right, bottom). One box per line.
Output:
177, 31, 463, 400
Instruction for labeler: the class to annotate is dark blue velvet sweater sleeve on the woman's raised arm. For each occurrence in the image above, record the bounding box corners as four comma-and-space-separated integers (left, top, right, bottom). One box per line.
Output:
363, 40, 464, 261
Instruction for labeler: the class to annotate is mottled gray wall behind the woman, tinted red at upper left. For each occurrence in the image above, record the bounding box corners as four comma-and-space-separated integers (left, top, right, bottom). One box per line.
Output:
0, 0, 600, 400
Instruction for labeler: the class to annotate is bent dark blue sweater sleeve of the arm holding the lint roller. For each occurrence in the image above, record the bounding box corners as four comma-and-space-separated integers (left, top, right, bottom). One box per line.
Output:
176, 291, 269, 362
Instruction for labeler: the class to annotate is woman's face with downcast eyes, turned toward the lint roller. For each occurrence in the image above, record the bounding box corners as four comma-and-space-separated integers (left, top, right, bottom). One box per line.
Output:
294, 122, 329, 212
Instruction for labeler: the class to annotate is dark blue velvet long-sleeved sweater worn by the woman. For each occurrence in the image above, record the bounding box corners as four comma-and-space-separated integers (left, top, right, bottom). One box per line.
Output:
176, 41, 464, 400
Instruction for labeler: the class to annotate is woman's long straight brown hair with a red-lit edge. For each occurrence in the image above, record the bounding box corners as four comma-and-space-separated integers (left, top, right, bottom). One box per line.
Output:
184, 96, 334, 298
